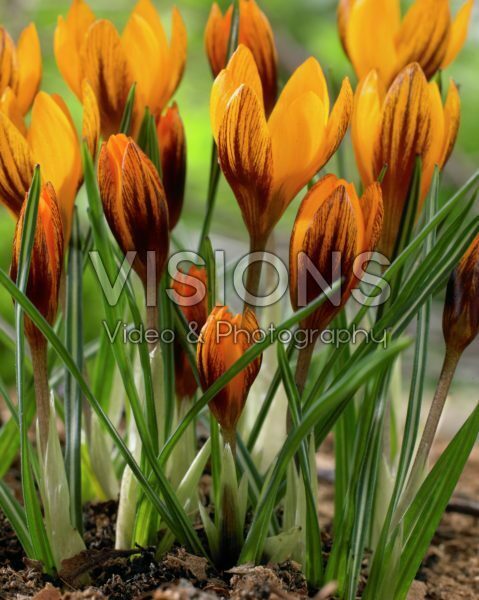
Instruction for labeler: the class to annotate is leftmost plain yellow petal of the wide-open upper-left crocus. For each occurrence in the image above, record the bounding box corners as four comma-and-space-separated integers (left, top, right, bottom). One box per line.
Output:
53, 0, 95, 99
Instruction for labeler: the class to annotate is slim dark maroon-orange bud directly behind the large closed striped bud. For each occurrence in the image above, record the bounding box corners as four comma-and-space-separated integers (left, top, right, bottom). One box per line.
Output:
157, 102, 186, 230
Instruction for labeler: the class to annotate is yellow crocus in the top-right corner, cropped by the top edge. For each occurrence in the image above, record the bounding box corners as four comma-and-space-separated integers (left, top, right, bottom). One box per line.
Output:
338, 0, 474, 85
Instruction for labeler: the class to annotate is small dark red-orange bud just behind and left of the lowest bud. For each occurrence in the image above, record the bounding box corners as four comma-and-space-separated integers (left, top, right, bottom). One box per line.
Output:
172, 265, 208, 399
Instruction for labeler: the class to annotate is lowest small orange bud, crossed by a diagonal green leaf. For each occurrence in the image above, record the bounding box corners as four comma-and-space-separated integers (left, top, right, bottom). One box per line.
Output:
197, 307, 261, 434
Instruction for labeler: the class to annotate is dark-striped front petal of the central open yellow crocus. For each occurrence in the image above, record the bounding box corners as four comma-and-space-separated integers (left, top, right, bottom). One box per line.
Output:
218, 86, 275, 240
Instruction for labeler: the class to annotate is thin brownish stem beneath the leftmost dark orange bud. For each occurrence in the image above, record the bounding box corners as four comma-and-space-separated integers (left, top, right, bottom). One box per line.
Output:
30, 339, 50, 455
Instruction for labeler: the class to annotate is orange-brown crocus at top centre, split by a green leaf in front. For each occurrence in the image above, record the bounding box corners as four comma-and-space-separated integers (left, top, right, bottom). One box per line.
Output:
205, 0, 278, 114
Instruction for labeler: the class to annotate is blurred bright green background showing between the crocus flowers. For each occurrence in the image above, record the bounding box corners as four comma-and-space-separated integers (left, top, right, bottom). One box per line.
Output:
0, 0, 479, 422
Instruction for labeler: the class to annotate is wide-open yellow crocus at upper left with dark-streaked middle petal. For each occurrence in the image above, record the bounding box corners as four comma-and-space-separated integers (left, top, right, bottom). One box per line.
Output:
54, 0, 186, 137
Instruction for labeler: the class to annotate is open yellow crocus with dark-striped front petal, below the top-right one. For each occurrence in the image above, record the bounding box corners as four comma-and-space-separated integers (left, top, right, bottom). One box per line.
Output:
352, 63, 460, 257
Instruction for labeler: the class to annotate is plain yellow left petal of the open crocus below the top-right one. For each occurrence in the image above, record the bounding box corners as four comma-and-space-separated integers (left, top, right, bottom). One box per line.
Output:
351, 71, 384, 185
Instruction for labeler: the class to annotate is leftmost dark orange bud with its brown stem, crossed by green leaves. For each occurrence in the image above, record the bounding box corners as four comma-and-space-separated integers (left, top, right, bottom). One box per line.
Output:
10, 182, 64, 451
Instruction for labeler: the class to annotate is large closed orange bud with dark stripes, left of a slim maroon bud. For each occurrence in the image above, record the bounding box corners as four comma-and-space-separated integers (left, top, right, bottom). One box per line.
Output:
98, 134, 169, 286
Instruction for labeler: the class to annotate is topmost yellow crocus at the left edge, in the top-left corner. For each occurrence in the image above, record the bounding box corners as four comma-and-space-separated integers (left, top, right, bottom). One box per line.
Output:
0, 23, 42, 117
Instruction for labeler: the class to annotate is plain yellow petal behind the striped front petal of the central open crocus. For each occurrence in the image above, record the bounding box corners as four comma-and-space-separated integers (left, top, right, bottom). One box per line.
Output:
210, 45, 263, 141
